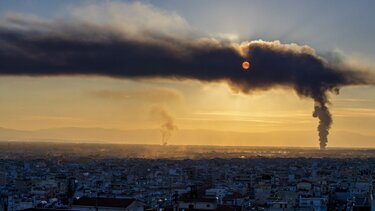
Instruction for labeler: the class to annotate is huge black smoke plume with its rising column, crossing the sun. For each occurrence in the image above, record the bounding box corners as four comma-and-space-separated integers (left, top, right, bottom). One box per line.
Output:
0, 16, 373, 148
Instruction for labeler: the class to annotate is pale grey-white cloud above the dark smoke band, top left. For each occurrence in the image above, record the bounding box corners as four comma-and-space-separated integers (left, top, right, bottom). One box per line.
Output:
70, 2, 193, 42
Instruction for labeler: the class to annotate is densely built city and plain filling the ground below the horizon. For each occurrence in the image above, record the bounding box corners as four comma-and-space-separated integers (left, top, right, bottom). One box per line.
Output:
0, 143, 375, 211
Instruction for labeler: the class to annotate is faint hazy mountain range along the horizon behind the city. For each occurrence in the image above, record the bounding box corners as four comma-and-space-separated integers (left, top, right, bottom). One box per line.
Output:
0, 127, 375, 147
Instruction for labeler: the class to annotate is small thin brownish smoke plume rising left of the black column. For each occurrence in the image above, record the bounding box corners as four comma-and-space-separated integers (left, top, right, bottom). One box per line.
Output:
150, 107, 178, 146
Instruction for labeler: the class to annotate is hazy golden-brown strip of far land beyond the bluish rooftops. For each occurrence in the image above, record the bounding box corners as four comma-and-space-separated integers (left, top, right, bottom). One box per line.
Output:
0, 141, 375, 161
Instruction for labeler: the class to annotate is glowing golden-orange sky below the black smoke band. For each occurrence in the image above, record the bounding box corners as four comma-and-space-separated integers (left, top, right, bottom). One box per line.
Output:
0, 77, 375, 147
